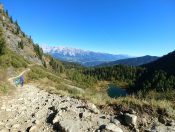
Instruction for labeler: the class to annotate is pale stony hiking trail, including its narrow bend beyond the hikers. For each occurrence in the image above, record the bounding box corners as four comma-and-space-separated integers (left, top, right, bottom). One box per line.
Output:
0, 69, 126, 132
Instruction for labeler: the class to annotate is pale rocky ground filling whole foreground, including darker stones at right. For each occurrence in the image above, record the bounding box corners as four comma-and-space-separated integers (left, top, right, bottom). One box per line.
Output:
0, 69, 175, 132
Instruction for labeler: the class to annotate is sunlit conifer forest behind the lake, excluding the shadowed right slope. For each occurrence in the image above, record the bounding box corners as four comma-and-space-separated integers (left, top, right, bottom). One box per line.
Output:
83, 65, 144, 84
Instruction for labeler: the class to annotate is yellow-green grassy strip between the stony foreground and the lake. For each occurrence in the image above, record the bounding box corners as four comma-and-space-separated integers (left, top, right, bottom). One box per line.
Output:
24, 66, 175, 118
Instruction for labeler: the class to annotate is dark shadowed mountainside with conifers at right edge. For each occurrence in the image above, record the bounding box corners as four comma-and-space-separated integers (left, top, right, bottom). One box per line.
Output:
134, 51, 175, 93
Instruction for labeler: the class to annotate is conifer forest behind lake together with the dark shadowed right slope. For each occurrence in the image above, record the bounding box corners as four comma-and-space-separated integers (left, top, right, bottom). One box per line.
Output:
80, 49, 175, 93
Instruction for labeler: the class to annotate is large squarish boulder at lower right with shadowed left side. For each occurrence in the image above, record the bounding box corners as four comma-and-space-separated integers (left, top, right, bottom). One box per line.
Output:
124, 113, 137, 126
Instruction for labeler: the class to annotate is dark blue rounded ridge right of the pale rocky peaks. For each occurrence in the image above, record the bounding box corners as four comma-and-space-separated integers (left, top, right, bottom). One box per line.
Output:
99, 55, 159, 66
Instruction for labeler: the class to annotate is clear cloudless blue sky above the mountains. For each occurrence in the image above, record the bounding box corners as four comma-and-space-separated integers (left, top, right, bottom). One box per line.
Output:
0, 0, 175, 56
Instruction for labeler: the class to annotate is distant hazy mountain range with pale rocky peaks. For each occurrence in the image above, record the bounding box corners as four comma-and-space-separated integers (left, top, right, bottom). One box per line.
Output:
42, 46, 130, 66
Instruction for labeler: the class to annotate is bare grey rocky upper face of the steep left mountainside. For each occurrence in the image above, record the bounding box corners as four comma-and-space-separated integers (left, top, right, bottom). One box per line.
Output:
0, 6, 42, 64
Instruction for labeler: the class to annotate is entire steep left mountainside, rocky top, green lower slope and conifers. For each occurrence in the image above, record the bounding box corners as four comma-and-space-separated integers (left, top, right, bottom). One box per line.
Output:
0, 4, 64, 72
